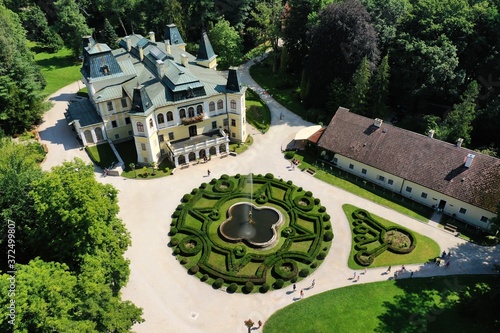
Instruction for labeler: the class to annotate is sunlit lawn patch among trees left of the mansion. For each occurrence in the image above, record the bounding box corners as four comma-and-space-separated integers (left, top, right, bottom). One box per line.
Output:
28, 42, 83, 96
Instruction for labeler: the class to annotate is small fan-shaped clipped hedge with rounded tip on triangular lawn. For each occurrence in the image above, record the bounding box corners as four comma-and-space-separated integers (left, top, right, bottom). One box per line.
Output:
352, 209, 417, 266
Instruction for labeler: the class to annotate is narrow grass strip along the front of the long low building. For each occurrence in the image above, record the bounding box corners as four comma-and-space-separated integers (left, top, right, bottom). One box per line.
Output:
292, 152, 433, 223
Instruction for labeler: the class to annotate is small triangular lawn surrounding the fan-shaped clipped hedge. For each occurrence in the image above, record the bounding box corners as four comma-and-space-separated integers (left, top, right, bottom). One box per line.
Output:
342, 205, 441, 269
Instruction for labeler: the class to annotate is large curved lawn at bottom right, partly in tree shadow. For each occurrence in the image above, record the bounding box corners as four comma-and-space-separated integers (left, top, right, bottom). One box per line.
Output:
263, 272, 499, 333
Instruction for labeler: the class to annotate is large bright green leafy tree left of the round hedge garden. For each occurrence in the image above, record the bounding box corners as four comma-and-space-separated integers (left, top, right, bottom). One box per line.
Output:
27, 159, 130, 292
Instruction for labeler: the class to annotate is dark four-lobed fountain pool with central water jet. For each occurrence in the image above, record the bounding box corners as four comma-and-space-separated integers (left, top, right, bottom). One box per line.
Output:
219, 174, 283, 247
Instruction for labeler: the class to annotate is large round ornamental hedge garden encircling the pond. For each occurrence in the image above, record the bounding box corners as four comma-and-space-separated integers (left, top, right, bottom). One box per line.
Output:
169, 174, 333, 293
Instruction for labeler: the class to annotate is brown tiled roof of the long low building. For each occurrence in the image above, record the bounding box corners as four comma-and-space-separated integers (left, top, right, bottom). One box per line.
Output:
318, 108, 500, 212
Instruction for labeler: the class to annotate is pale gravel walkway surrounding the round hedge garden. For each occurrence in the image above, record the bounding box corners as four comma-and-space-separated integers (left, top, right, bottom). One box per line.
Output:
41, 63, 500, 333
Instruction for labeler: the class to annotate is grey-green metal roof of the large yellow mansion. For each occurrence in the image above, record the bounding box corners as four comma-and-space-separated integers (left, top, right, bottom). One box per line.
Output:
81, 25, 238, 114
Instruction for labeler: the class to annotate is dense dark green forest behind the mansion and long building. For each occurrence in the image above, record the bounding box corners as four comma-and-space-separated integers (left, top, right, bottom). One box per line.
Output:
0, 0, 500, 156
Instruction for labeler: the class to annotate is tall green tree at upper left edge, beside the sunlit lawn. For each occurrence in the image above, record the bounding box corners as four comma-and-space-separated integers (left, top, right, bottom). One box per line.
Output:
0, 5, 48, 135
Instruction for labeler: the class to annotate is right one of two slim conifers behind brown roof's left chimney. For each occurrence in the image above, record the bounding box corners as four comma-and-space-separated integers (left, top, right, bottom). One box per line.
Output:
370, 54, 390, 118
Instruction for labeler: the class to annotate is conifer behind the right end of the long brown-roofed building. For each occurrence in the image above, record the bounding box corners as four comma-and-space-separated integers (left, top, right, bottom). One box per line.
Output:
444, 81, 479, 144
